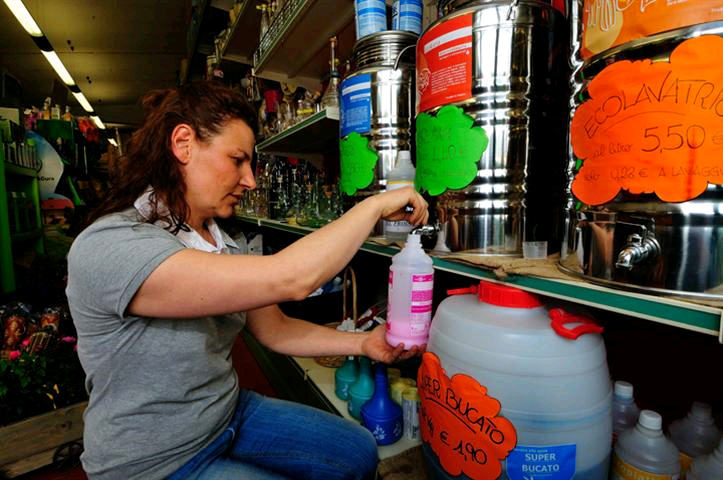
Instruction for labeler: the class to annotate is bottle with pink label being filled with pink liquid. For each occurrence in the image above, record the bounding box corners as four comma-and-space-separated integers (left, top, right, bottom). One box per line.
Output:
387, 233, 434, 349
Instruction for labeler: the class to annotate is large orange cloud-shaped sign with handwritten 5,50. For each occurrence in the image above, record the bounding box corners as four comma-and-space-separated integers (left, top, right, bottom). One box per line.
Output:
570, 35, 723, 205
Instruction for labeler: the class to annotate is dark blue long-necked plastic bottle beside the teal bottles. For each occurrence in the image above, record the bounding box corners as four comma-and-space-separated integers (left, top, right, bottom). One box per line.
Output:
361, 363, 404, 445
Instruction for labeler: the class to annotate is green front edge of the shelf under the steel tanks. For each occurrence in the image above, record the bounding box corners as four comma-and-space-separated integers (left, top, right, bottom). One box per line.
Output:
238, 217, 723, 343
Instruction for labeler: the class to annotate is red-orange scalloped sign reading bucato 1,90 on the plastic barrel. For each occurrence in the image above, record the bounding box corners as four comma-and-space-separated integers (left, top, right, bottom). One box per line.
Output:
417, 352, 517, 480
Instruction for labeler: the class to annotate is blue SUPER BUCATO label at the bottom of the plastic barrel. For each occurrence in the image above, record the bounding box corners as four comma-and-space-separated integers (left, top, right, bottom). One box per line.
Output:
507, 444, 576, 480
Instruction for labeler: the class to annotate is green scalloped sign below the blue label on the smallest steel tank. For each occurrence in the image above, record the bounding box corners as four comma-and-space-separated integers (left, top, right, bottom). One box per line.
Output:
339, 132, 379, 195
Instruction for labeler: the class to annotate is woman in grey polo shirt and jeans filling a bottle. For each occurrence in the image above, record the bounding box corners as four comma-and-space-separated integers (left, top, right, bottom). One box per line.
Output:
66, 82, 428, 480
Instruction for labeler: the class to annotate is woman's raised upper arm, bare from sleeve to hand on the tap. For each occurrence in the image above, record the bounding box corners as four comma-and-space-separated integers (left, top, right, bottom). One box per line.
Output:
127, 187, 429, 318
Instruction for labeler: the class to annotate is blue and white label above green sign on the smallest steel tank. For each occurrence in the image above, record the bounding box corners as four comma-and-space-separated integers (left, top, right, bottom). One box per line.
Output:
339, 73, 372, 138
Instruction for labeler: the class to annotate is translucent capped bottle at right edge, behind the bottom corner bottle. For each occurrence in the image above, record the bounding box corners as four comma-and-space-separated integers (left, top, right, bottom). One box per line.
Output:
668, 402, 723, 478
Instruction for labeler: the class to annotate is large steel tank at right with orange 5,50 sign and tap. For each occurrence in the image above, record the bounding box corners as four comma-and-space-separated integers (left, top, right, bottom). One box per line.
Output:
560, 0, 723, 300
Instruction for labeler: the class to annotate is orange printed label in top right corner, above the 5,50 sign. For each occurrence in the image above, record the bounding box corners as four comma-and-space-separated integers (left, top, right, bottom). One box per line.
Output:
580, 0, 723, 59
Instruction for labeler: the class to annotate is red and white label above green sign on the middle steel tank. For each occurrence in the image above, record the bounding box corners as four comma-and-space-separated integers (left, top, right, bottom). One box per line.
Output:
417, 13, 472, 112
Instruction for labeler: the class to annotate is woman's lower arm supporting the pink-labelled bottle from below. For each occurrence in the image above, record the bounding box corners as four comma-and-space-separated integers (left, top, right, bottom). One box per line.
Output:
246, 305, 420, 363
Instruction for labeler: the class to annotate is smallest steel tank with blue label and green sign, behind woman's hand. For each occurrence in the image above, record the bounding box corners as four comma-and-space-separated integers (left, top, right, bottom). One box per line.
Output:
340, 30, 417, 202
